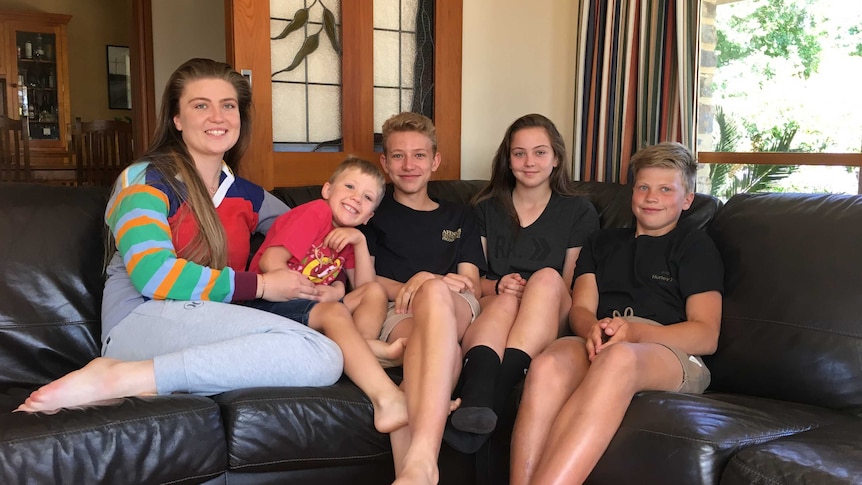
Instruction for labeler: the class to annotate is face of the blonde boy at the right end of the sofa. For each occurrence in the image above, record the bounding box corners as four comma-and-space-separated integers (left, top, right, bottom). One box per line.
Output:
632, 167, 694, 236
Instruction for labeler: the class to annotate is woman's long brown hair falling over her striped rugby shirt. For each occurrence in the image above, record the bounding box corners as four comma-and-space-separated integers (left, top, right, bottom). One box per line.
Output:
126, 58, 252, 268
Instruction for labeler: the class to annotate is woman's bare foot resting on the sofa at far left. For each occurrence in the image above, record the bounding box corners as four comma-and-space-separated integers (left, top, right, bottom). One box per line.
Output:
16, 357, 156, 413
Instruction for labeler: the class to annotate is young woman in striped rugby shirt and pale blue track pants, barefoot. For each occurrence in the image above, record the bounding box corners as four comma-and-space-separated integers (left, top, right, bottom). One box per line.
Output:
18, 59, 342, 412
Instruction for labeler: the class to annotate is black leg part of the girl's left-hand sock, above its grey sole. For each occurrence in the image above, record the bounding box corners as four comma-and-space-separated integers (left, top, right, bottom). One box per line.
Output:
455, 345, 500, 408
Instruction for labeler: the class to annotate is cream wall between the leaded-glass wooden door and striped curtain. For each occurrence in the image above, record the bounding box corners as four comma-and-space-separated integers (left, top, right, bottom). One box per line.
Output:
462, 0, 579, 179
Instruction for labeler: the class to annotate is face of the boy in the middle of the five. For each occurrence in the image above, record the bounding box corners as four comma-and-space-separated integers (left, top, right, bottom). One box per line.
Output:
380, 131, 440, 194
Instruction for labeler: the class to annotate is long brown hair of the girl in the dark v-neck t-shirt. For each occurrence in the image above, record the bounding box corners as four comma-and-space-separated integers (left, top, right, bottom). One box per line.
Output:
473, 113, 578, 230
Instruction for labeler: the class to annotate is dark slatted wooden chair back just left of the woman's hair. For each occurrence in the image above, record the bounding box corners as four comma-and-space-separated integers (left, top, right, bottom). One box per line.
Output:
72, 118, 134, 187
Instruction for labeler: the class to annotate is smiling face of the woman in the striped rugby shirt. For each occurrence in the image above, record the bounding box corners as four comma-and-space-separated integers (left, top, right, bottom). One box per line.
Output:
174, 78, 240, 164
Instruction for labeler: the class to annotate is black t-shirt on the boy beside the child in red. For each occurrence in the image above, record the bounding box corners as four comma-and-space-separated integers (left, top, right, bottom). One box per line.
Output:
361, 193, 485, 283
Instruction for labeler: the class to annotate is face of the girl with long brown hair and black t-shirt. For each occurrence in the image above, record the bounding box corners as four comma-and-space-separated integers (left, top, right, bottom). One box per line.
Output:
509, 127, 559, 188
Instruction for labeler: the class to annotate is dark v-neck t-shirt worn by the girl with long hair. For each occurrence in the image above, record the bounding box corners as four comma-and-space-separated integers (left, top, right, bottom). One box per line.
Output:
476, 192, 599, 280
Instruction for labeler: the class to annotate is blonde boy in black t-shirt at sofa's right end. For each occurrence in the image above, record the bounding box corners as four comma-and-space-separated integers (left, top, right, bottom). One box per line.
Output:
510, 143, 723, 485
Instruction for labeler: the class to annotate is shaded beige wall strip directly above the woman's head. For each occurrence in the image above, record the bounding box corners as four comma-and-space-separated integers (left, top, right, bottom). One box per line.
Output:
152, 0, 227, 113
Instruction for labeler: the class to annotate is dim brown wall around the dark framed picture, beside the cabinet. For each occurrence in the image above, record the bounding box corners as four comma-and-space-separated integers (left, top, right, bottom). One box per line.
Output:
0, 0, 132, 119
